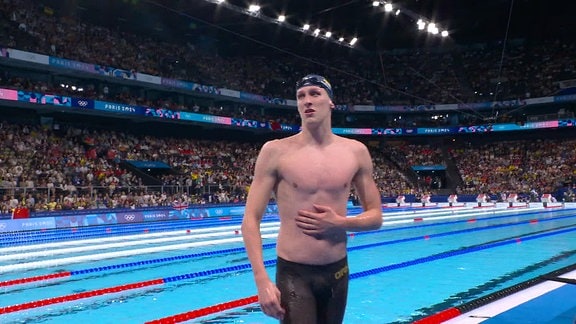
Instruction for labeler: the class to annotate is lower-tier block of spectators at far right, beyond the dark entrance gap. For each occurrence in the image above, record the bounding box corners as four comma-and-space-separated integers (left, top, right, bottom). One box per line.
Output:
450, 138, 576, 200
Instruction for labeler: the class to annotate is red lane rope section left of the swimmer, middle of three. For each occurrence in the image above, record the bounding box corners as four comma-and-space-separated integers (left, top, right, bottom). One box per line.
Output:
0, 279, 164, 314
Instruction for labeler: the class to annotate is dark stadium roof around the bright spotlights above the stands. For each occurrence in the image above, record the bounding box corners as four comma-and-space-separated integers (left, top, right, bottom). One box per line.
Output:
45, 0, 576, 53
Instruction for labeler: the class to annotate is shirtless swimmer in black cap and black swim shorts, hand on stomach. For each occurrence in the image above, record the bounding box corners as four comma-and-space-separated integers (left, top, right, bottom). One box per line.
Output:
242, 75, 382, 324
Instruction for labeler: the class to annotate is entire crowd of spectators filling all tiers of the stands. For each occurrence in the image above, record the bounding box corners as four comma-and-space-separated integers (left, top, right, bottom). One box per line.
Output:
0, 0, 576, 212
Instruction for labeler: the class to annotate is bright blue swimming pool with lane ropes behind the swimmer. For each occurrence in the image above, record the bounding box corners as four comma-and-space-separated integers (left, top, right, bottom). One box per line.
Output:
0, 207, 576, 324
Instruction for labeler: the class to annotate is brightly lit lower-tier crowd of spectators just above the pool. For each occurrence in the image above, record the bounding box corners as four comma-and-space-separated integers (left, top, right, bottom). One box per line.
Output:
0, 115, 576, 213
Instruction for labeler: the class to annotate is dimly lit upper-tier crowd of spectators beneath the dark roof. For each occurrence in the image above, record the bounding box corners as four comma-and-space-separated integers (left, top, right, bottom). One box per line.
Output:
0, 0, 576, 109
